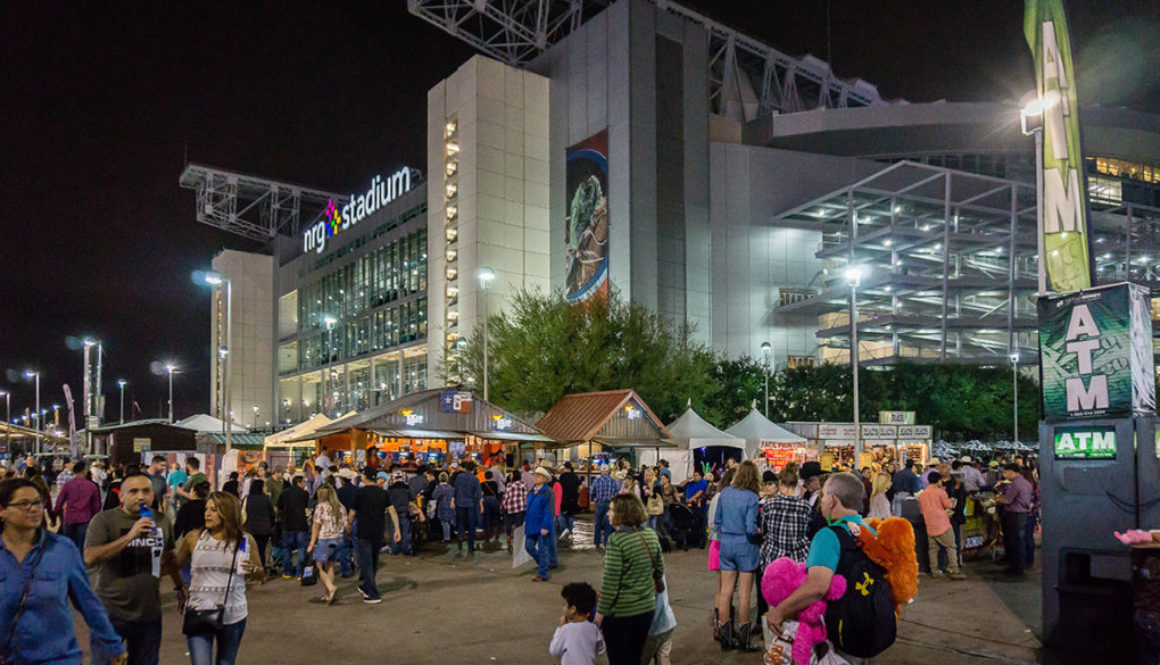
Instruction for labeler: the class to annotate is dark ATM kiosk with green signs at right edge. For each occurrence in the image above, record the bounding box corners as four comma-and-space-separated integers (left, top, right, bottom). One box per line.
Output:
1038, 284, 1160, 664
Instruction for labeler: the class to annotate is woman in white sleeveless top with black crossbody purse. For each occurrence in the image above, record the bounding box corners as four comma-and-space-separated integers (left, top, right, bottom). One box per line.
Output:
177, 492, 266, 665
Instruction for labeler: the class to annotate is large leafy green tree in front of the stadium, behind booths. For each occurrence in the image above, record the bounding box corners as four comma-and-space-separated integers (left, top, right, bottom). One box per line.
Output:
443, 291, 717, 422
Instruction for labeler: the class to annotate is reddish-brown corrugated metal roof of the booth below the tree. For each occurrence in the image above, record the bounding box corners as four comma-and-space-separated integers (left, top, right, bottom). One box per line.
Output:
536, 389, 670, 443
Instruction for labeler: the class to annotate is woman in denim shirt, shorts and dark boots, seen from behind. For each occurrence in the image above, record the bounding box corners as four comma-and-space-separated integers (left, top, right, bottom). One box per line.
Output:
713, 462, 761, 651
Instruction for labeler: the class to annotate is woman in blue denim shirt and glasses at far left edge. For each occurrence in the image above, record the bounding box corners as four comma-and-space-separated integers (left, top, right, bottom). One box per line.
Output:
0, 478, 126, 665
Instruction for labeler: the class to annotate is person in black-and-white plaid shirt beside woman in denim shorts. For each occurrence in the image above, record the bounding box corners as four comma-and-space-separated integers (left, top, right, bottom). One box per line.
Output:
757, 468, 810, 616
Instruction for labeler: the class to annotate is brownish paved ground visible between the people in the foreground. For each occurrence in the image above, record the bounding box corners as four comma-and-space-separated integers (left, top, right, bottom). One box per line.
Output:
78, 524, 1039, 665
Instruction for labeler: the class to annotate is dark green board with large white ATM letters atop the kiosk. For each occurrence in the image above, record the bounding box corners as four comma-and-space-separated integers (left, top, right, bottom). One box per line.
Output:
1038, 283, 1155, 422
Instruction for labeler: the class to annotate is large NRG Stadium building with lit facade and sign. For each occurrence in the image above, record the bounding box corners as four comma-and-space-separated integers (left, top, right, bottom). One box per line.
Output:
181, 0, 1160, 424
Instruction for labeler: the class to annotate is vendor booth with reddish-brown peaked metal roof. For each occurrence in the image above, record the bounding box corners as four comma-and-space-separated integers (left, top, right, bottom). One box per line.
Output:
536, 390, 681, 473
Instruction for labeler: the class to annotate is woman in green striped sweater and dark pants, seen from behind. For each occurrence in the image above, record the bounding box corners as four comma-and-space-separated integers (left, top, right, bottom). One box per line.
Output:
596, 494, 665, 665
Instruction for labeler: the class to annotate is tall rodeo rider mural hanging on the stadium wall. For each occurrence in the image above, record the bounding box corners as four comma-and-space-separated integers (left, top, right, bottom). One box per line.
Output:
564, 131, 608, 304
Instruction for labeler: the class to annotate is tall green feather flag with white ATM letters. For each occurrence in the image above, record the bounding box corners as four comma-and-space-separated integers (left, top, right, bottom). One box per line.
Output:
1023, 0, 1092, 292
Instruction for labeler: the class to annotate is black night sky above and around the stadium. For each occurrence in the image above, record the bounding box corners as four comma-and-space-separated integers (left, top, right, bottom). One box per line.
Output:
0, 0, 1160, 419
